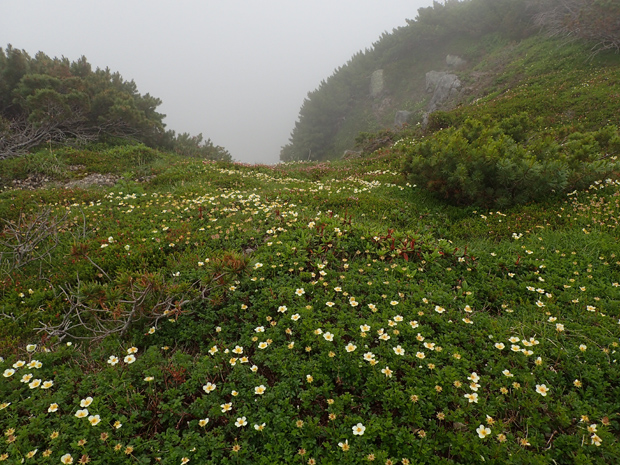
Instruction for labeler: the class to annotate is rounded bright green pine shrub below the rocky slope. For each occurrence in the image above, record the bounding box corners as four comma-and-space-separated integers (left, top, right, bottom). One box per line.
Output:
404, 113, 620, 207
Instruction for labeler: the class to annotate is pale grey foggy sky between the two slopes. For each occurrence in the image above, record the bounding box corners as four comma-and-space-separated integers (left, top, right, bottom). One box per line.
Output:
0, 0, 432, 163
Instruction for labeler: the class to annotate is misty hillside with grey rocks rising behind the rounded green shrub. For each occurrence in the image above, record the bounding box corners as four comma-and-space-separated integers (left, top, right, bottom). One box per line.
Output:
281, 0, 620, 161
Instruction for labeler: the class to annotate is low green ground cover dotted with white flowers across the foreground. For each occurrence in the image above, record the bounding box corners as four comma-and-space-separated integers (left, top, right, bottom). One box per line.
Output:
0, 153, 620, 464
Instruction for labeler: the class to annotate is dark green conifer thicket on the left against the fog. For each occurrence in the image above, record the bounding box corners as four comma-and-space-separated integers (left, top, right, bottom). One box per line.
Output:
0, 45, 230, 160
